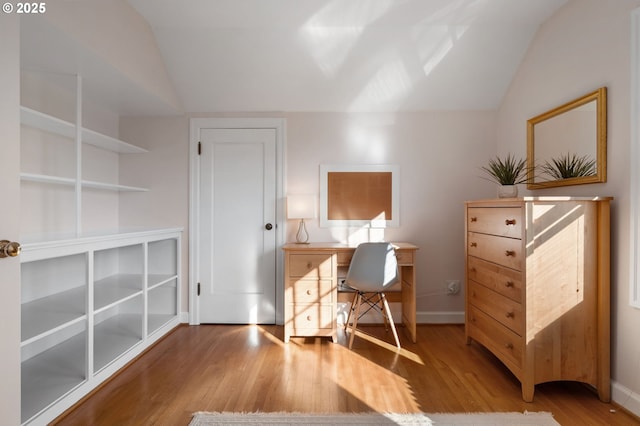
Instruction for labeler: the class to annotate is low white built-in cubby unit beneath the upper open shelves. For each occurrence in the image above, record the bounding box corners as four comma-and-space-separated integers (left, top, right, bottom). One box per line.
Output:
20, 229, 181, 424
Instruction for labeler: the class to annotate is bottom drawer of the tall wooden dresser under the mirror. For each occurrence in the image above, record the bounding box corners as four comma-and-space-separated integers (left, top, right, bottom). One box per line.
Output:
467, 306, 524, 375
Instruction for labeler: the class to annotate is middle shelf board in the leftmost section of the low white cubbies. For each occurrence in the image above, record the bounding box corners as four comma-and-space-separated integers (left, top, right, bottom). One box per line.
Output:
21, 287, 87, 346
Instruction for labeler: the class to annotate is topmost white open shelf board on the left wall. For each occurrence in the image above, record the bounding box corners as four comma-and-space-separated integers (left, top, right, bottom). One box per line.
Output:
20, 107, 148, 154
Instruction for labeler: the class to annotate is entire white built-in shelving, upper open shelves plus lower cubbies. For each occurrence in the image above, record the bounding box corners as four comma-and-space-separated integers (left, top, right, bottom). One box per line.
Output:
20, 77, 182, 425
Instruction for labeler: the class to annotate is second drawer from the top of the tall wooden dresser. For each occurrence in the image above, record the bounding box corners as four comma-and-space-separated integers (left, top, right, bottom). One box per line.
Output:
467, 232, 524, 271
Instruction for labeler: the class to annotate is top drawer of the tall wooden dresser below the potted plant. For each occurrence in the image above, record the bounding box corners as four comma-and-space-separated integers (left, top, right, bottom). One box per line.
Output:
467, 207, 523, 238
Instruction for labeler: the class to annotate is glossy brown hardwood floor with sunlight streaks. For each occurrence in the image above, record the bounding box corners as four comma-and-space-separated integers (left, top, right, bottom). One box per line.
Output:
55, 325, 640, 425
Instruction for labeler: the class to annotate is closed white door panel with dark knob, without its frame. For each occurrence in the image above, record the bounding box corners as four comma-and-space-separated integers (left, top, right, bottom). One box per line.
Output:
198, 129, 276, 324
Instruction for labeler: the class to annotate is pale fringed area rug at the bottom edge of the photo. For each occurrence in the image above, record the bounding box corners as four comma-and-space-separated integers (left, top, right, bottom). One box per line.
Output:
189, 411, 559, 426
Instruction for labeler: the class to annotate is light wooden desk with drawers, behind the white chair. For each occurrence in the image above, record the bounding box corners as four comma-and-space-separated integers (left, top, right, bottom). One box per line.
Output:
282, 243, 418, 343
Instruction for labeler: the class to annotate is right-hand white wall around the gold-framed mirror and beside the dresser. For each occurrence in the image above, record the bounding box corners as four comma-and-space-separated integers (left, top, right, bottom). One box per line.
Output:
497, 0, 640, 414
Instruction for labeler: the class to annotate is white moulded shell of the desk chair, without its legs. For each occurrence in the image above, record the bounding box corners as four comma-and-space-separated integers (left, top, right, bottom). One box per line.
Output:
346, 243, 399, 293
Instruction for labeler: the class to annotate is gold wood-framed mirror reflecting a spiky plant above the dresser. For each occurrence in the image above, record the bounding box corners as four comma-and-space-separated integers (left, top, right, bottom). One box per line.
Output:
527, 87, 607, 189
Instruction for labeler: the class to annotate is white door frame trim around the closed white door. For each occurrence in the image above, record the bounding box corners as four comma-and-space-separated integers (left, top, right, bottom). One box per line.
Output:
189, 118, 286, 325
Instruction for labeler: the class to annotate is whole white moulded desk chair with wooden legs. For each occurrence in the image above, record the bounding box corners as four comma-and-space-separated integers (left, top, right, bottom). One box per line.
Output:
345, 243, 400, 349
